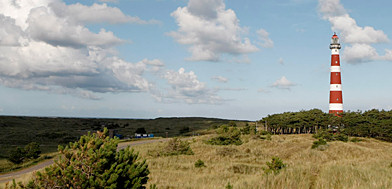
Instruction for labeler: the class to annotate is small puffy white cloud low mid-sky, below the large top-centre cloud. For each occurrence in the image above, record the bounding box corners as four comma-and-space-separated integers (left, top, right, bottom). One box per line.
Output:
162, 68, 222, 104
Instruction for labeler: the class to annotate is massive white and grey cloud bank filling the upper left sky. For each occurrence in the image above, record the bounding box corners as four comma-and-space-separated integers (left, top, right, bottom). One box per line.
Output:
0, 0, 163, 99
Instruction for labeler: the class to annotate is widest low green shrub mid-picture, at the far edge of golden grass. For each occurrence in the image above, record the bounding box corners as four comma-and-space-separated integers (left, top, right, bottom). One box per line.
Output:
207, 126, 242, 145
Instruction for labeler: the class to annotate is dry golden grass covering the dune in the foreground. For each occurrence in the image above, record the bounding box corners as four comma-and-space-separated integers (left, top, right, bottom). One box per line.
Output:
134, 135, 392, 189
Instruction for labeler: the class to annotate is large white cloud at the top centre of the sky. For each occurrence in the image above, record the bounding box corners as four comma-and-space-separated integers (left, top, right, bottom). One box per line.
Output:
168, 0, 258, 61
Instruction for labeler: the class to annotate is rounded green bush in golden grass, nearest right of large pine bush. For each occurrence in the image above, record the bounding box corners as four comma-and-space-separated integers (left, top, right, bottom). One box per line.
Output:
163, 138, 194, 156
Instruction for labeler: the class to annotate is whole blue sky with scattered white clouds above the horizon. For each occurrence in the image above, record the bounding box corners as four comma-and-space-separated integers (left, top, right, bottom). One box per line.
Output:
0, 0, 392, 120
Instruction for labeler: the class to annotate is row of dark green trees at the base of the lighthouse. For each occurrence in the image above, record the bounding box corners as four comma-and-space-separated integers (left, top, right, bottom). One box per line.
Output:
258, 109, 392, 141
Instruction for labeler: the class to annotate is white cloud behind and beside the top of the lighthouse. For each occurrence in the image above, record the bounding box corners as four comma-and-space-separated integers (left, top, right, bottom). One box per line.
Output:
318, 0, 389, 64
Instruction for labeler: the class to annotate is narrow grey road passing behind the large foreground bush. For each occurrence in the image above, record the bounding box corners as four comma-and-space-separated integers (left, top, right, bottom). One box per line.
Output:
0, 138, 169, 183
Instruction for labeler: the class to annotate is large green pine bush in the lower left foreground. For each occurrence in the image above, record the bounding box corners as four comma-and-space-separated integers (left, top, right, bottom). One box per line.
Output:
22, 128, 149, 188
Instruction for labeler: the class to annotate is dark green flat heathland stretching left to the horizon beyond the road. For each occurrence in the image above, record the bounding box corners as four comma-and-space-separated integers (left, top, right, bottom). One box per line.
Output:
0, 116, 245, 159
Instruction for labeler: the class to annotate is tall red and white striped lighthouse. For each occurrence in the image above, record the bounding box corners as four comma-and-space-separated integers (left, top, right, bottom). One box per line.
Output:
329, 33, 343, 115
